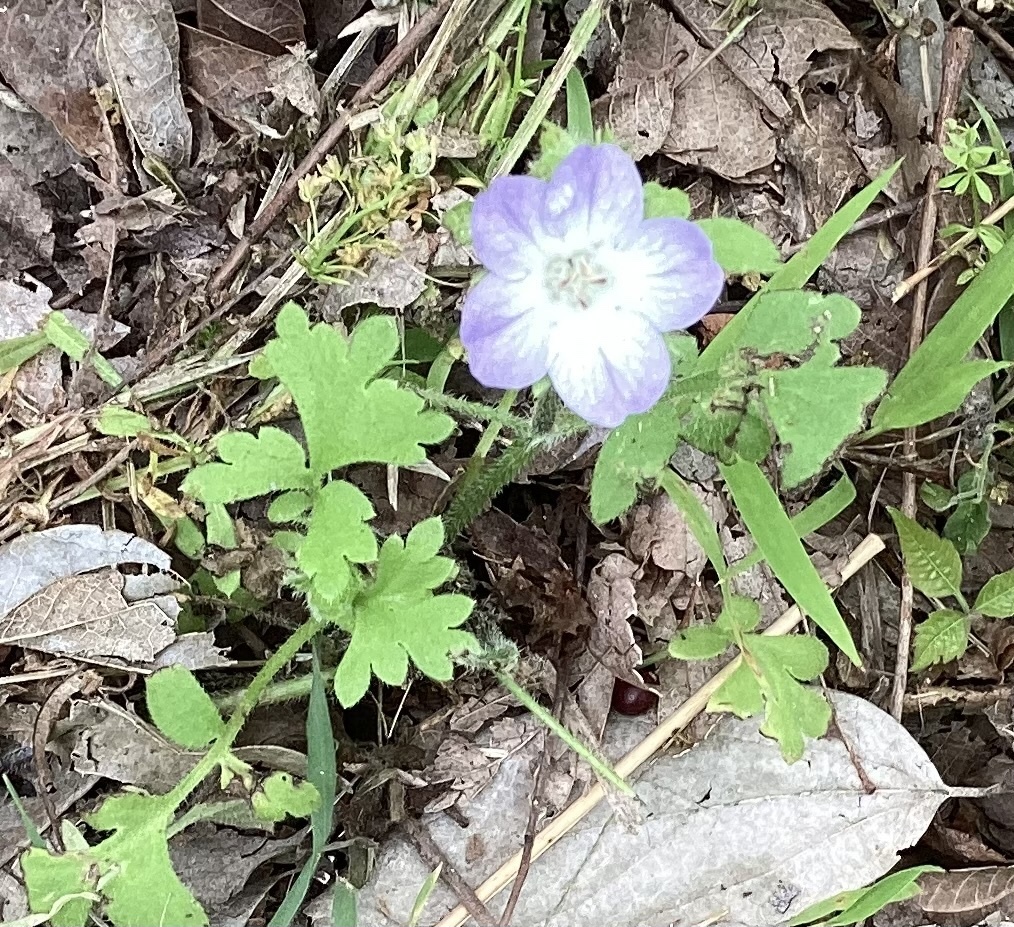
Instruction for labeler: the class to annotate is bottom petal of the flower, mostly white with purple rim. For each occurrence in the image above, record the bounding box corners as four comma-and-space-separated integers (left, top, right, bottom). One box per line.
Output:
549, 309, 671, 428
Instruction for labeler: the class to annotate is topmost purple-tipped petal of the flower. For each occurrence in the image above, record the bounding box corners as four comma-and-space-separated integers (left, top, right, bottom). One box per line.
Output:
542, 145, 644, 247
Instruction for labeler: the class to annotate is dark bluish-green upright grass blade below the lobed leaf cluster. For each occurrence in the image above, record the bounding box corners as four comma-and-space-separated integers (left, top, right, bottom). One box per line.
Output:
268, 641, 336, 927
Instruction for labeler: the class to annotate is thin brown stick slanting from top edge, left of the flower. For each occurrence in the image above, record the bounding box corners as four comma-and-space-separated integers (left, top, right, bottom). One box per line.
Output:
208, 0, 451, 293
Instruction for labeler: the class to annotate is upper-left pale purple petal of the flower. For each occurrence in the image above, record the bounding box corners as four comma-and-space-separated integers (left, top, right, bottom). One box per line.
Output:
472, 176, 549, 279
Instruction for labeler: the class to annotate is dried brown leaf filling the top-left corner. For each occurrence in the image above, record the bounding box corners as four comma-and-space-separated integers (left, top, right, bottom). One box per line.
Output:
0, 0, 107, 157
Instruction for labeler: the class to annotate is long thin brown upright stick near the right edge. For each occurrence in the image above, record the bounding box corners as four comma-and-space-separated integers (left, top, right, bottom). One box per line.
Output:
890, 27, 975, 721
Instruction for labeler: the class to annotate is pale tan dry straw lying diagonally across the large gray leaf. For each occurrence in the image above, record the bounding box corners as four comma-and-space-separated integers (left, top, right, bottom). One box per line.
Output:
436, 534, 884, 927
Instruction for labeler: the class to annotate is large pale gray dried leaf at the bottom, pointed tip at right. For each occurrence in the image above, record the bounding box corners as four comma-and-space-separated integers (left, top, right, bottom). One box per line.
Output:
359, 693, 951, 927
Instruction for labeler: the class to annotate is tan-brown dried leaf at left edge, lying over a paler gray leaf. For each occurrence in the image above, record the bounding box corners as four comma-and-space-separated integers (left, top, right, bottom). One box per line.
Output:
0, 570, 176, 662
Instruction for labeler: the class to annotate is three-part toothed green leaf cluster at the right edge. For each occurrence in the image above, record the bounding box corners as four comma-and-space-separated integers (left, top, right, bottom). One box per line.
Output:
889, 508, 1014, 671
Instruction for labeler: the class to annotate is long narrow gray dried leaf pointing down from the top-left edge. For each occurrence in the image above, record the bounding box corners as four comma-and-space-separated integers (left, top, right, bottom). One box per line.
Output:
99, 0, 193, 167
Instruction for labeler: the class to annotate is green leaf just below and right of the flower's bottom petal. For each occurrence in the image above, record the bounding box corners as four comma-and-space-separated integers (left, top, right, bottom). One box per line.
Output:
591, 400, 679, 524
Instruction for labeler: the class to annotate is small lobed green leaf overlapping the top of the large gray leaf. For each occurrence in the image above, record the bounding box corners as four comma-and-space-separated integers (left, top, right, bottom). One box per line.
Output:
744, 634, 830, 763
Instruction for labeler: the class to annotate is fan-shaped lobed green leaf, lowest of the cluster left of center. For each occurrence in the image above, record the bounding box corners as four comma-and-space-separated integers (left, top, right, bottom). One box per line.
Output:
335, 518, 475, 707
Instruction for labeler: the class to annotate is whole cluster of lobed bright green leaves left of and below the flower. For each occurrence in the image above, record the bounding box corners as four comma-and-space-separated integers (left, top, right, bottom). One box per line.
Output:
183, 303, 473, 706
